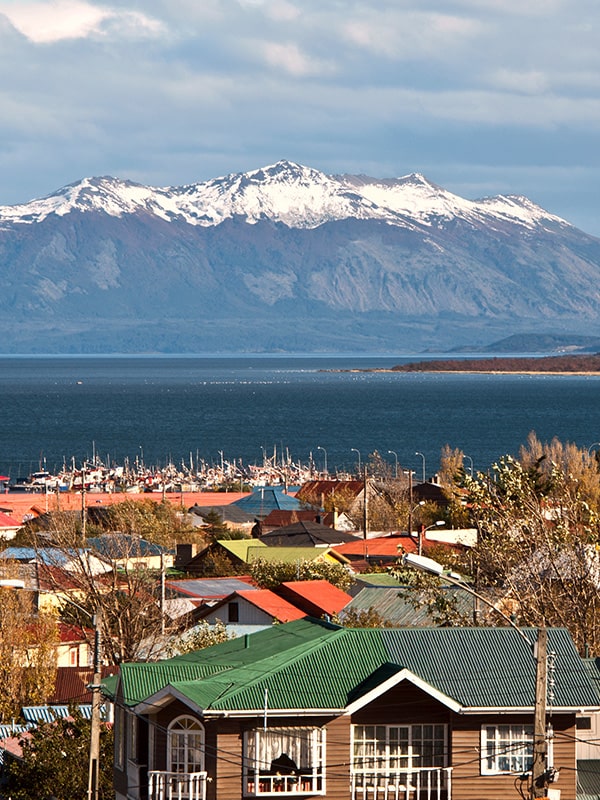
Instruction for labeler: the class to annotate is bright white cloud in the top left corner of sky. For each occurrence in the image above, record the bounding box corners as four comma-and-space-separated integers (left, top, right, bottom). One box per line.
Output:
0, 0, 162, 44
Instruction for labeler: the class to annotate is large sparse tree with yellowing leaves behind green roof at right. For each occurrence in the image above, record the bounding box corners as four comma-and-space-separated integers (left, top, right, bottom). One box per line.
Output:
467, 456, 600, 655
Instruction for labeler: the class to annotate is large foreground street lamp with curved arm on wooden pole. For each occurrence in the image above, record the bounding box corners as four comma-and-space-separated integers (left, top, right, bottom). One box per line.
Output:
402, 553, 548, 798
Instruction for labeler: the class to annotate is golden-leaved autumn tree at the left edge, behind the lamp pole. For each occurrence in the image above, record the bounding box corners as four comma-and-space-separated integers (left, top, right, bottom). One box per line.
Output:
0, 588, 58, 722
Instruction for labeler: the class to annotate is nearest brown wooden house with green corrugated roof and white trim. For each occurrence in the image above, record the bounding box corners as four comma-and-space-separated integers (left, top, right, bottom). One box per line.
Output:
114, 618, 600, 800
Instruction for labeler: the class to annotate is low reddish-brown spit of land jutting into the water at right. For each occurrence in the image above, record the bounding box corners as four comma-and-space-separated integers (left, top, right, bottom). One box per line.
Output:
392, 353, 600, 373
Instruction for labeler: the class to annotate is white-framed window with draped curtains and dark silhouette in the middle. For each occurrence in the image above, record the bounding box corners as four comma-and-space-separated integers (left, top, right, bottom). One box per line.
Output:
244, 727, 325, 796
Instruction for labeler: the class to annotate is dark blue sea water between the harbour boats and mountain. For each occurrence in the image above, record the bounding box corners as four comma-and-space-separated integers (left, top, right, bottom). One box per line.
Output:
0, 355, 600, 479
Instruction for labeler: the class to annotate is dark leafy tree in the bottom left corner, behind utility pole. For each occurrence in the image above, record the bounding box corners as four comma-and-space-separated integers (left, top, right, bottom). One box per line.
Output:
5, 709, 114, 800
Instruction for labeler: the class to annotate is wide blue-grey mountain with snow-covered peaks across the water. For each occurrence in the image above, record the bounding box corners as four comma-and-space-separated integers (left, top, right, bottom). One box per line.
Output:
0, 161, 600, 352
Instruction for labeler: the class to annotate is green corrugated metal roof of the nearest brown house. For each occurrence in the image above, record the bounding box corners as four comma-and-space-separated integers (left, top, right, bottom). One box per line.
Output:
116, 619, 600, 714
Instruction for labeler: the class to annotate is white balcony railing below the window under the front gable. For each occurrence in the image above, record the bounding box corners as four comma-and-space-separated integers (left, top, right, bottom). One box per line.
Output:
352, 767, 452, 800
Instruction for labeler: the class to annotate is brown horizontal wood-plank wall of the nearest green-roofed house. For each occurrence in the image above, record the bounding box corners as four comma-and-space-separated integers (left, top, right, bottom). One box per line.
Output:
138, 683, 576, 800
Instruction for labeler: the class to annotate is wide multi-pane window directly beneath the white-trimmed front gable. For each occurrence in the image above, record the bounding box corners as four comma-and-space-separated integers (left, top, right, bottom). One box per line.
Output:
352, 725, 448, 792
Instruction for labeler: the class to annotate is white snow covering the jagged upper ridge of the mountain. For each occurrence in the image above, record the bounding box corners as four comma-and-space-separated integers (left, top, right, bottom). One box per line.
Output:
0, 160, 566, 228
